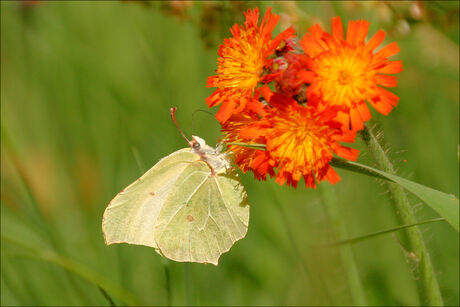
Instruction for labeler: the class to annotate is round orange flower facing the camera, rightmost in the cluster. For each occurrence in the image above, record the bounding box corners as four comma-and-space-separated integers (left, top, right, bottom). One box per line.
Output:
300, 17, 402, 130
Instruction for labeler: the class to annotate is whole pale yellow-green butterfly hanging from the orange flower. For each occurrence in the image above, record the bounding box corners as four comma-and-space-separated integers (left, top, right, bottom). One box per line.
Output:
102, 108, 249, 265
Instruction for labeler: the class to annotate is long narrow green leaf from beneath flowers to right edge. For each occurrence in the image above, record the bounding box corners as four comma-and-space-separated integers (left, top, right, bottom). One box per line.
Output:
330, 158, 459, 231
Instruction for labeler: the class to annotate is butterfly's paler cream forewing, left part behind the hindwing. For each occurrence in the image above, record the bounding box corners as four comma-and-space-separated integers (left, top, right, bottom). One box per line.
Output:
102, 148, 201, 249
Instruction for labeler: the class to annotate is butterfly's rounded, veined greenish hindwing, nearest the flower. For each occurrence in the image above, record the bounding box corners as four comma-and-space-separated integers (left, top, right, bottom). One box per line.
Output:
154, 167, 249, 265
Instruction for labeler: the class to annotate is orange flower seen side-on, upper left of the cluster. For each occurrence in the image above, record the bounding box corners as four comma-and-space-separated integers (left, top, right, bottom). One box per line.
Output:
206, 8, 294, 123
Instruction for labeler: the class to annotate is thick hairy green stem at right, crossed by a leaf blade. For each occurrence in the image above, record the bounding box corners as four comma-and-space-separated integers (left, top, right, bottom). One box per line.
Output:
361, 127, 443, 306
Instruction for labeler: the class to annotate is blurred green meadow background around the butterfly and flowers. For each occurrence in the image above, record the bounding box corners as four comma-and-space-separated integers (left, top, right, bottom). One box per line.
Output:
0, 1, 459, 305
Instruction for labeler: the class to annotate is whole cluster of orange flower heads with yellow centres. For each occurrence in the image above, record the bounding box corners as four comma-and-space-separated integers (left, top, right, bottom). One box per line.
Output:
206, 8, 402, 187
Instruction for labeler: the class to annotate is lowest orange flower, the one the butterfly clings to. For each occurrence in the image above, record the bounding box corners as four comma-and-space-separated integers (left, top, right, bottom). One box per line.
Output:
224, 93, 358, 187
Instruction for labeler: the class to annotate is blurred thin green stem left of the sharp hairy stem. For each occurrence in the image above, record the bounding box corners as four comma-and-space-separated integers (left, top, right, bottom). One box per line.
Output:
320, 184, 367, 306
